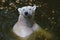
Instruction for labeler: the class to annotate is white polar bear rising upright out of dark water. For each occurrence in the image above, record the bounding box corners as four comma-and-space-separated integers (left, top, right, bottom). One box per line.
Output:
13, 5, 52, 40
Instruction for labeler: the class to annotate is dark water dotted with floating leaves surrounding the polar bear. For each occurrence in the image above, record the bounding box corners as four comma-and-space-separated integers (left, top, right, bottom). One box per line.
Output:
0, 0, 60, 40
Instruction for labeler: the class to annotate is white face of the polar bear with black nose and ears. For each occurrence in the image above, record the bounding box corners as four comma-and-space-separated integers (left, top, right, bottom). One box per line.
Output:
18, 6, 36, 17
